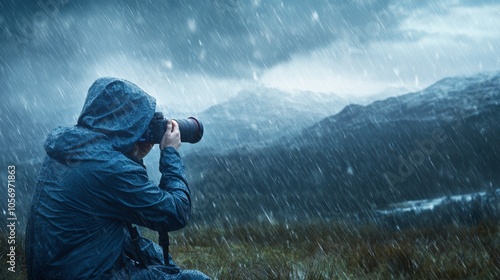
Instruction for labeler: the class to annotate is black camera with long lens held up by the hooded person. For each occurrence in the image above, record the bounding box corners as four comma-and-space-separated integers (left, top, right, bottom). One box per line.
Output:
139, 112, 203, 144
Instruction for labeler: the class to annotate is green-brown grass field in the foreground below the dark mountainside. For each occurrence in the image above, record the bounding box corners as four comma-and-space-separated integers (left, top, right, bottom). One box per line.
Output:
0, 222, 500, 279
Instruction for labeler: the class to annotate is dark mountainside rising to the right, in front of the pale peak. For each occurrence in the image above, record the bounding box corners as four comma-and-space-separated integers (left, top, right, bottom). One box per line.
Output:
186, 73, 500, 224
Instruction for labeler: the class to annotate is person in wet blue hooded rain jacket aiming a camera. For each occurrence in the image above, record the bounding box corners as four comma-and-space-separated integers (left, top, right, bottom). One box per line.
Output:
25, 78, 208, 279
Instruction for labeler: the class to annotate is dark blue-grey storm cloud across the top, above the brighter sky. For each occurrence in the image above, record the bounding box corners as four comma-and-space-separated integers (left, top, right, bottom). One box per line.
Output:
1, 0, 399, 77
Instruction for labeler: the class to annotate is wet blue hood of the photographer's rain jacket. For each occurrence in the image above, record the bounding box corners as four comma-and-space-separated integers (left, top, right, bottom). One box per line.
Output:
45, 78, 156, 159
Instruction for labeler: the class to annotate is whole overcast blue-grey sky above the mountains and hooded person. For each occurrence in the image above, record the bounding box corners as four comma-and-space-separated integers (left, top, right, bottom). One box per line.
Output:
0, 0, 500, 112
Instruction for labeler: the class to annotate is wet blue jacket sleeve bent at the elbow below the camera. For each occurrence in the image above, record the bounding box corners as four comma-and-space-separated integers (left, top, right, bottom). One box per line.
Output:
103, 147, 191, 231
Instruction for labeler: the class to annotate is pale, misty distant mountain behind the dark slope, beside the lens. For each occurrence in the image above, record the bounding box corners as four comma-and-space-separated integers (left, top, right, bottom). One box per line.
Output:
182, 87, 362, 152
